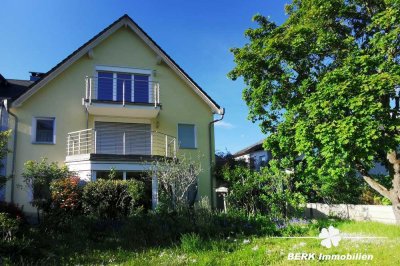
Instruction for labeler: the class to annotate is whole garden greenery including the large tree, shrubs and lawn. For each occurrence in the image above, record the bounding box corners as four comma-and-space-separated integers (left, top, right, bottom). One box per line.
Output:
0, 0, 400, 265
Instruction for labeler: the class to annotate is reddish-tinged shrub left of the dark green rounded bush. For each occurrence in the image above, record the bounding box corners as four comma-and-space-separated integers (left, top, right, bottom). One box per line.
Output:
50, 177, 83, 214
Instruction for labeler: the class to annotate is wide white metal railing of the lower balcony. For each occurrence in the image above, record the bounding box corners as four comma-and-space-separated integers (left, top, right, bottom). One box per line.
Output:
67, 129, 177, 157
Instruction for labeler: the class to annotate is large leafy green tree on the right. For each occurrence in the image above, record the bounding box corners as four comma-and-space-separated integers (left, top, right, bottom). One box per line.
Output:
229, 0, 400, 223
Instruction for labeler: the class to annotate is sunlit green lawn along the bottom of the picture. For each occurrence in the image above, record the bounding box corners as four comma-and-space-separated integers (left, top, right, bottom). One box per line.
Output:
50, 220, 400, 265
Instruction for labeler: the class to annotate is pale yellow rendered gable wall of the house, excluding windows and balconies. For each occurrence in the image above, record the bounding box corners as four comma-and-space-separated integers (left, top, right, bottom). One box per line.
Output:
7, 27, 214, 212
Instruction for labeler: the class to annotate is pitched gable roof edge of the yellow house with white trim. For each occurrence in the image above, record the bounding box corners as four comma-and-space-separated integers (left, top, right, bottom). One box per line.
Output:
13, 14, 224, 114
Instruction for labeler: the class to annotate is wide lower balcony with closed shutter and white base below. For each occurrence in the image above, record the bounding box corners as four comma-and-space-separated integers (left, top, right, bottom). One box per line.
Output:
65, 128, 177, 209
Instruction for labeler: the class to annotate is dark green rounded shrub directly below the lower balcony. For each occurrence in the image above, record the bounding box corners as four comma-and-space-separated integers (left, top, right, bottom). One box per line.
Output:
82, 180, 144, 219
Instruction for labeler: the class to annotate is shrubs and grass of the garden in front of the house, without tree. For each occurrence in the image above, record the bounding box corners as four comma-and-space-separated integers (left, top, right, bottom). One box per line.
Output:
0, 156, 400, 265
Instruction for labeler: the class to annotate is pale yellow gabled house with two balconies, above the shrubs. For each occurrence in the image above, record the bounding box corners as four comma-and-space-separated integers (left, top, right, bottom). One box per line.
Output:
0, 15, 224, 212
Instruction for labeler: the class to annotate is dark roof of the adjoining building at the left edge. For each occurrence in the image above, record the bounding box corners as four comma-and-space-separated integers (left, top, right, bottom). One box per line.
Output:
0, 74, 32, 101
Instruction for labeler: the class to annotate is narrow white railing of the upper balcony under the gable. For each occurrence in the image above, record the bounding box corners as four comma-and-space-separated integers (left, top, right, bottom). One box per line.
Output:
85, 77, 160, 107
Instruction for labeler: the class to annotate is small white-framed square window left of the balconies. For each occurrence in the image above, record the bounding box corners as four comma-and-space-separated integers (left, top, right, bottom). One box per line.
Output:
32, 117, 56, 144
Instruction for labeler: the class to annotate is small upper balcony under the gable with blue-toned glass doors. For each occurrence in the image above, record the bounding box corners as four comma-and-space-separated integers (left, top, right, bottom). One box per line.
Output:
83, 75, 160, 118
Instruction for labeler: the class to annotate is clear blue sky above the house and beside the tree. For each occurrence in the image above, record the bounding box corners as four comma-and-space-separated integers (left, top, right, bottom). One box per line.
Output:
0, 0, 289, 152
